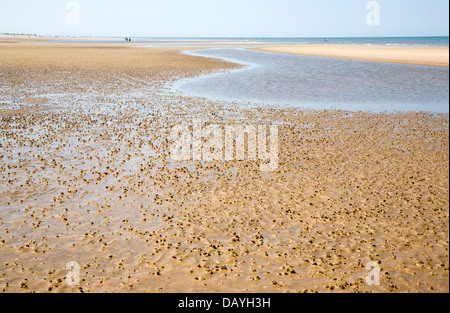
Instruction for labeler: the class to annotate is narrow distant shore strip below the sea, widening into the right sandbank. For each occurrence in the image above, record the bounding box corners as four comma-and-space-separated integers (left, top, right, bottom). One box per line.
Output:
0, 36, 449, 68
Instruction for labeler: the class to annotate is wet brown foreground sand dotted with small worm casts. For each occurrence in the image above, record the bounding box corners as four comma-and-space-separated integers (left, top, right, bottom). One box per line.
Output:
0, 43, 449, 292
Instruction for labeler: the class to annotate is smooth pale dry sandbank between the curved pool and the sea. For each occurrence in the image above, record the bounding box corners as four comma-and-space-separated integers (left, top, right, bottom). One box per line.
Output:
255, 45, 449, 67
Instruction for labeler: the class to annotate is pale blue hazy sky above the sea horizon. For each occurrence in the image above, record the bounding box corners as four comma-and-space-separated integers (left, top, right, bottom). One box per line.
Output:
0, 0, 449, 37
